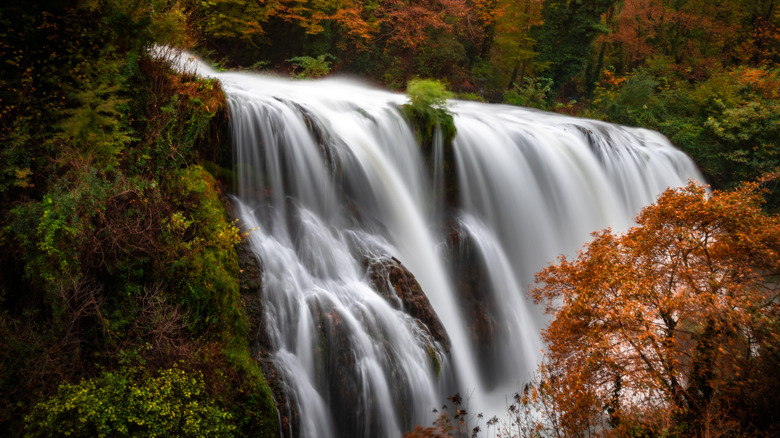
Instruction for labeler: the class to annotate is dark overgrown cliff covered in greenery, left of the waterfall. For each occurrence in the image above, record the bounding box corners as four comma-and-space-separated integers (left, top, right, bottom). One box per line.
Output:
0, 19, 278, 436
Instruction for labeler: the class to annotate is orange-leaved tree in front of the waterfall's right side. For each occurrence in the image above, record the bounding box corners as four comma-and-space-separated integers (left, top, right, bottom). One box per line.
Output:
531, 179, 780, 436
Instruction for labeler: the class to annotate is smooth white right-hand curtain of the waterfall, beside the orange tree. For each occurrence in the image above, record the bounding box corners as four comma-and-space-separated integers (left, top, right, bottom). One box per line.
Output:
454, 102, 701, 412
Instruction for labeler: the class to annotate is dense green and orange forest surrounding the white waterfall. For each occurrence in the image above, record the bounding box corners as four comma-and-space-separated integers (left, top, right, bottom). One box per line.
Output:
0, 0, 780, 436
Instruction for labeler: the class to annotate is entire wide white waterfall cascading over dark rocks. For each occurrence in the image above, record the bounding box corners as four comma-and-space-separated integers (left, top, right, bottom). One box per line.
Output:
174, 54, 701, 437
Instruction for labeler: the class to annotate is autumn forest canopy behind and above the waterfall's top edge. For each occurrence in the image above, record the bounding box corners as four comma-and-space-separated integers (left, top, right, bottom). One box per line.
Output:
192, 0, 780, 202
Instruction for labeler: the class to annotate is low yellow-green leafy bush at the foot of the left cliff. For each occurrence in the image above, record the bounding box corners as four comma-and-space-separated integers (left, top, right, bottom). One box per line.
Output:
25, 368, 236, 437
